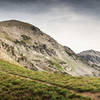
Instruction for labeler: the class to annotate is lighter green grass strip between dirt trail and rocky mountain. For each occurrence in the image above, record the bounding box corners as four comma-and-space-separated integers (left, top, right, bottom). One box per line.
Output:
0, 60, 100, 92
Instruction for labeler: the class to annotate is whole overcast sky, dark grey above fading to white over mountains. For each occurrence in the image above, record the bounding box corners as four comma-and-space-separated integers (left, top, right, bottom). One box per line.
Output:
0, 0, 100, 52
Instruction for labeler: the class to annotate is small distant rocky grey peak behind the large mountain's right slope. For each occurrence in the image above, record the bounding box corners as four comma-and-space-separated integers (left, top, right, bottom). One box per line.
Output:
78, 50, 100, 70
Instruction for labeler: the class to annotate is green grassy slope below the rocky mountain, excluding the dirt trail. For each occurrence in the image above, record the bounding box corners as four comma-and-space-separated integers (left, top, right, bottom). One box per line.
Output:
0, 60, 100, 100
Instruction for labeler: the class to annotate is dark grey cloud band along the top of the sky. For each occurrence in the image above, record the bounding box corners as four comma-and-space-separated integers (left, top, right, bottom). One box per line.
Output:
0, 0, 100, 17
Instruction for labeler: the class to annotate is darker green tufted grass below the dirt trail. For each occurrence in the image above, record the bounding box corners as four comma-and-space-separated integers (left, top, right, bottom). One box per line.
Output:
0, 72, 91, 100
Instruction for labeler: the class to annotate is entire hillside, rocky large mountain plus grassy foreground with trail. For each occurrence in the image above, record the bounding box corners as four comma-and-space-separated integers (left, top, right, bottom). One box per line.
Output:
0, 20, 100, 100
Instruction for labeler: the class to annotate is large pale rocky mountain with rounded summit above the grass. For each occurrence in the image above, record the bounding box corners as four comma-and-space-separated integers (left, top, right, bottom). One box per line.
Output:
0, 20, 100, 76
